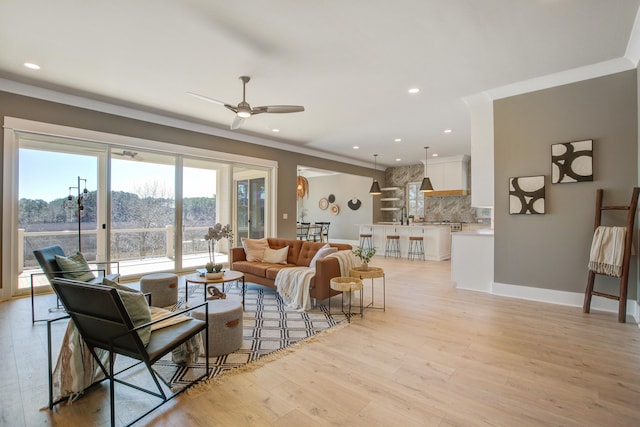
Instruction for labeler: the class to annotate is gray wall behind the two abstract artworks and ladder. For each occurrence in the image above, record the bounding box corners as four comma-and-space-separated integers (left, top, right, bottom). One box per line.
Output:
494, 70, 638, 299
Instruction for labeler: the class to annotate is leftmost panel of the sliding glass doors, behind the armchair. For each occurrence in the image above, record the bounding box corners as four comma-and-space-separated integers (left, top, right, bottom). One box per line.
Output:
17, 135, 106, 293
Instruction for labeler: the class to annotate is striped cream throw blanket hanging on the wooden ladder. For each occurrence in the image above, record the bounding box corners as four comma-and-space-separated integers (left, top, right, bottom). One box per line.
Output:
589, 226, 627, 277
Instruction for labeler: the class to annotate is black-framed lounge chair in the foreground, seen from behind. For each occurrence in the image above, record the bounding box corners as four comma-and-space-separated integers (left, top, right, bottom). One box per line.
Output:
47, 278, 209, 426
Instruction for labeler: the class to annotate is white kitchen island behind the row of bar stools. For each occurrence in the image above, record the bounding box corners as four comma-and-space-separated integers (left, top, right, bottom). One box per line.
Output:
359, 223, 451, 261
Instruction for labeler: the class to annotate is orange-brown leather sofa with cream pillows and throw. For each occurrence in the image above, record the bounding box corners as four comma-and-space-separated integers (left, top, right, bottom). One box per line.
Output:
229, 237, 351, 300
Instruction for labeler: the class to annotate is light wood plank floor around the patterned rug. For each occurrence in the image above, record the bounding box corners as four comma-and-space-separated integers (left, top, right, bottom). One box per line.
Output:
0, 257, 640, 427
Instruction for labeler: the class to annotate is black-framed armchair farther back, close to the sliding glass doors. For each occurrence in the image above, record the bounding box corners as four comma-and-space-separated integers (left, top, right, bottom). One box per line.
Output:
31, 245, 120, 323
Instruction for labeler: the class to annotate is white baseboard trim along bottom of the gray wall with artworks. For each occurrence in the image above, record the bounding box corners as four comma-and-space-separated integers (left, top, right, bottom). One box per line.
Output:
488, 282, 640, 326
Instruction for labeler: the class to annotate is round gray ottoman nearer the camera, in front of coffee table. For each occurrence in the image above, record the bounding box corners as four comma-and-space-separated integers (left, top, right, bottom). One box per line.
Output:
191, 295, 243, 357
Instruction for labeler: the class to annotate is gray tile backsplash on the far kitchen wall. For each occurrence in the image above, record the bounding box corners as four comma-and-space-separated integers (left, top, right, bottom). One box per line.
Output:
381, 164, 477, 222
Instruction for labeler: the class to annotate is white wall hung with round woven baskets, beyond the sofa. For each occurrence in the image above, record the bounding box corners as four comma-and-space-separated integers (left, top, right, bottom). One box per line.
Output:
296, 174, 373, 241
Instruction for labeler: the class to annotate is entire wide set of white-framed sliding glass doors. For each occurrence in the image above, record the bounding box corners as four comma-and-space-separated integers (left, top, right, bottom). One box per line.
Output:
2, 119, 275, 295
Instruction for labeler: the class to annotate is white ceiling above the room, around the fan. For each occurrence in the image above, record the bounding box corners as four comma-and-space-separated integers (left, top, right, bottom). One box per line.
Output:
0, 0, 640, 166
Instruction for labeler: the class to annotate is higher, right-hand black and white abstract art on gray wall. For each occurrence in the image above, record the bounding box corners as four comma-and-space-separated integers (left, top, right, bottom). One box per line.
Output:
551, 139, 593, 184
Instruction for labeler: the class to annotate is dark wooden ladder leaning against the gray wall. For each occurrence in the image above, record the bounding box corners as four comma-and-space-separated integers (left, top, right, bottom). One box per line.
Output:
582, 187, 640, 323
